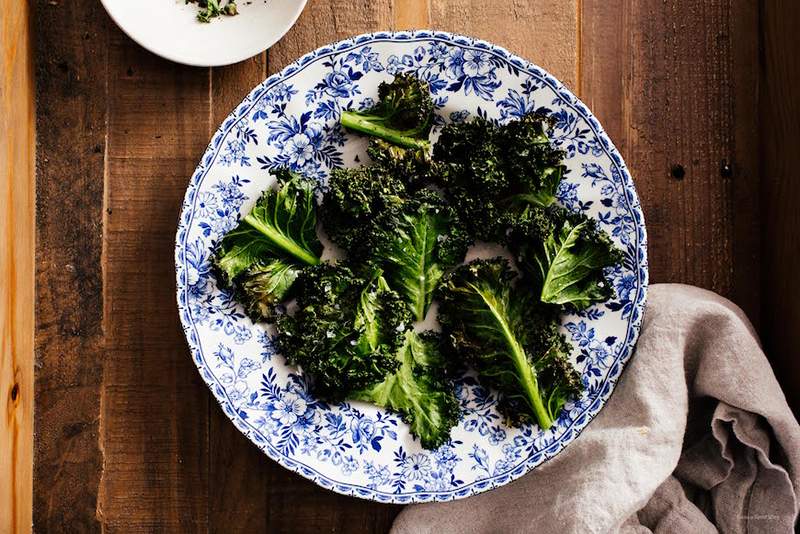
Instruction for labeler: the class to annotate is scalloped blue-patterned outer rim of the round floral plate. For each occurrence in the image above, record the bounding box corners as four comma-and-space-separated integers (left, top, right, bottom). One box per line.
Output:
175, 30, 649, 504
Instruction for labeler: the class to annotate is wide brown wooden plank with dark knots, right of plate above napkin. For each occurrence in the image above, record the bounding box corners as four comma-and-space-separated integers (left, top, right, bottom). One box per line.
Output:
579, 0, 758, 318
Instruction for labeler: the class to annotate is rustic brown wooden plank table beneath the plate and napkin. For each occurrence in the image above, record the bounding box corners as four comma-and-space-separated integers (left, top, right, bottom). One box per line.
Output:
0, 0, 800, 533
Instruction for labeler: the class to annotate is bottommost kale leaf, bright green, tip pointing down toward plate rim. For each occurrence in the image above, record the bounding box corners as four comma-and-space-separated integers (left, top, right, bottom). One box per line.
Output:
352, 330, 459, 449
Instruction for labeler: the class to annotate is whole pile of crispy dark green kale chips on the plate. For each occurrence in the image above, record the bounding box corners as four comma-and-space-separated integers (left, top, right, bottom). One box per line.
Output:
214, 74, 620, 449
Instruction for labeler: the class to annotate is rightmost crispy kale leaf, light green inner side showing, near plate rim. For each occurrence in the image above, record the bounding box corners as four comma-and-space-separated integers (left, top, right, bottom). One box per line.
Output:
510, 206, 622, 310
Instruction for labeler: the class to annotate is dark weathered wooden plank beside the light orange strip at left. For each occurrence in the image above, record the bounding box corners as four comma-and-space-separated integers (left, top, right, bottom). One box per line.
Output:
33, 0, 109, 532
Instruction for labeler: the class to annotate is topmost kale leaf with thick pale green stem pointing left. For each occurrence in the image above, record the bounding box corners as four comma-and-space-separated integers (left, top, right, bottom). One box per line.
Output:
341, 73, 433, 150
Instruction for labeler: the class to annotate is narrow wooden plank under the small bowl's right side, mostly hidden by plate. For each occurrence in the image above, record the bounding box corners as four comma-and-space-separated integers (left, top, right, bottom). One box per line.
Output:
208, 53, 280, 533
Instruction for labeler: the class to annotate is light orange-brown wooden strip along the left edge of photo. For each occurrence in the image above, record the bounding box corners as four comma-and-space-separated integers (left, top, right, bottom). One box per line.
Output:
0, 0, 36, 532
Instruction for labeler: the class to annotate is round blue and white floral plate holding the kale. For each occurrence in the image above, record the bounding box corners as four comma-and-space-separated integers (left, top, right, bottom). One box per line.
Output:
175, 31, 647, 503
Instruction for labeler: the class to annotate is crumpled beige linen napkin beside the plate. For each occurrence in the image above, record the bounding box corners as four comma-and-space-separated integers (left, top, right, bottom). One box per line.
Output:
392, 284, 800, 534
